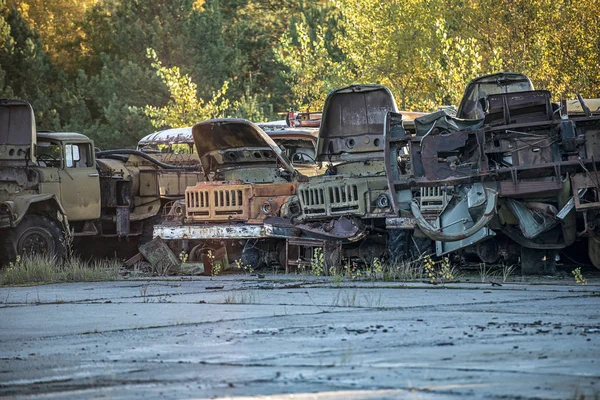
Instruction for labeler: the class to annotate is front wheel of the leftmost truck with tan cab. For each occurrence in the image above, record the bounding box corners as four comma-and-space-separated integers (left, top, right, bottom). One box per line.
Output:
8, 215, 66, 259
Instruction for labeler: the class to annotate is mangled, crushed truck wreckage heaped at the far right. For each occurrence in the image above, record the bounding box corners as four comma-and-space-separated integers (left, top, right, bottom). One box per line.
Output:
385, 73, 600, 273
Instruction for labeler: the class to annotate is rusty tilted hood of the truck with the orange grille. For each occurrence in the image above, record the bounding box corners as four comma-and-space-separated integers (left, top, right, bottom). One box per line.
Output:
192, 118, 294, 174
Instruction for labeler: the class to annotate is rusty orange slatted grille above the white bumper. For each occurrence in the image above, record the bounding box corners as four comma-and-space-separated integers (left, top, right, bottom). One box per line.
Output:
185, 184, 251, 220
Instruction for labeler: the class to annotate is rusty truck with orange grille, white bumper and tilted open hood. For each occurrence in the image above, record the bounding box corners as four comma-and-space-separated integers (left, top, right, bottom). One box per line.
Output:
154, 119, 303, 268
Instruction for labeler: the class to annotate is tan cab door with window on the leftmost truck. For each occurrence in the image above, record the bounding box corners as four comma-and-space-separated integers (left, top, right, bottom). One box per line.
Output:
59, 142, 100, 221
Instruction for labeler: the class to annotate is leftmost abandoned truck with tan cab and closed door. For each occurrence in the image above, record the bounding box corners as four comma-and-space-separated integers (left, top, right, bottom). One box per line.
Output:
0, 99, 204, 262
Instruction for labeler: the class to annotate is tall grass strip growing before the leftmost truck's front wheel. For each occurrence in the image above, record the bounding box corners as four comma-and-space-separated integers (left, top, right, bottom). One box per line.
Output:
0, 254, 121, 285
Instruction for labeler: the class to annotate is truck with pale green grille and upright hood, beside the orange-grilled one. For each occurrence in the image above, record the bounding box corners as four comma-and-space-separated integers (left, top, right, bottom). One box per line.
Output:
286, 85, 404, 267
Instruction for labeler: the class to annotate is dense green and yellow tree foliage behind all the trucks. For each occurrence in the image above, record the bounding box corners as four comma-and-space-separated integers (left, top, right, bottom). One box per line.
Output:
0, 0, 600, 148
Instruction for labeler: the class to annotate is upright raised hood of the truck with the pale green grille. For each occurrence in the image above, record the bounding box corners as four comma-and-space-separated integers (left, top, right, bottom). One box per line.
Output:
317, 85, 397, 161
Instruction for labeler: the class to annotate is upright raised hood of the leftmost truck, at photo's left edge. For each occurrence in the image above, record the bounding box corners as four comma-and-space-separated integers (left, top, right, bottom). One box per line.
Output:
0, 99, 36, 163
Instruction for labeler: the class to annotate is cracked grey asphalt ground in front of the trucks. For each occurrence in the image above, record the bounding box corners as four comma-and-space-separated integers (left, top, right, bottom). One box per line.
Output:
0, 275, 600, 400
